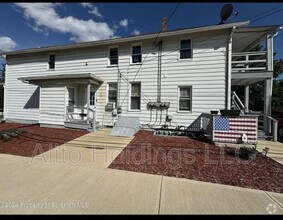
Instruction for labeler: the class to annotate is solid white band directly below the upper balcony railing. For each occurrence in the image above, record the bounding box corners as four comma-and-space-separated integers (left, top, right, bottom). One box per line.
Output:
231, 71, 273, 86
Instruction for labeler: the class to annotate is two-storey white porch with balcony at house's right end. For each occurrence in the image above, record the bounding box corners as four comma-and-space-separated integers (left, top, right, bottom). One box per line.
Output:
231, 26, 279, 135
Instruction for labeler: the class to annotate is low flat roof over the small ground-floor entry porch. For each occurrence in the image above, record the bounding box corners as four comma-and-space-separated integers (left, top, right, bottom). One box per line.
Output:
18, 73, 103, 85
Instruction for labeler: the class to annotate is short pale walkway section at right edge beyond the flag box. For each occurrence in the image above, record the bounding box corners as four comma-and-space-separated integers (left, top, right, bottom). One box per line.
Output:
257, 140, 283, 165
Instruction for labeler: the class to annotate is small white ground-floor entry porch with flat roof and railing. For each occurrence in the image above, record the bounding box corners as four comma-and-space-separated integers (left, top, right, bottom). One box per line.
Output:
19, 73, 103, 131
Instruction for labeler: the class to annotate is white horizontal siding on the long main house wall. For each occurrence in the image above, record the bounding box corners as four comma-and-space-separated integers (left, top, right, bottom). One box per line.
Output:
5, 31, 228, 126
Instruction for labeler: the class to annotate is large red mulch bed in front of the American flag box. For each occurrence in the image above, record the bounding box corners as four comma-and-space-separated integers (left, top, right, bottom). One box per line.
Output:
108, 131, 283, 193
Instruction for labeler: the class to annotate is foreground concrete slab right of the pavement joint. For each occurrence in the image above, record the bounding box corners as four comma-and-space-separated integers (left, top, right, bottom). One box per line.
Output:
160, 177, 283, 214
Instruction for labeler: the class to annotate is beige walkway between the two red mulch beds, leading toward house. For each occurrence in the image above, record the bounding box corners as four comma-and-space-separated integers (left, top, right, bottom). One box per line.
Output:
29, 128, 133, 168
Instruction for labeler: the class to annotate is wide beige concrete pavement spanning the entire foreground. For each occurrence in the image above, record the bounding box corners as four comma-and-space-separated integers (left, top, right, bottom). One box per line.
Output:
0, 152, 283, 214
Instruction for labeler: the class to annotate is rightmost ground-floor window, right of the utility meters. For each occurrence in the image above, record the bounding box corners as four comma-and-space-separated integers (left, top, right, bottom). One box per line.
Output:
178, 86, 192, 111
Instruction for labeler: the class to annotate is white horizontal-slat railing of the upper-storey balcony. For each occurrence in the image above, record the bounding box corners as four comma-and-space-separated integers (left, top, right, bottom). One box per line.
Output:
232, 51, 267, 72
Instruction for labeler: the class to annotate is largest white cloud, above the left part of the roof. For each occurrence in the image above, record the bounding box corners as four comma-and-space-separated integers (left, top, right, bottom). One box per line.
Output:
15, 3, 114, 42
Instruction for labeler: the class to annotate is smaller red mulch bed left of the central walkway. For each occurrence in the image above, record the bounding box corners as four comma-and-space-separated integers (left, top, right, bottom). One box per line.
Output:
0, 123, 88, 157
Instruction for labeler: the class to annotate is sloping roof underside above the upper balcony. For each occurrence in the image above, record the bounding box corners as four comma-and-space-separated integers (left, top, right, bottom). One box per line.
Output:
232, 25, 280, 53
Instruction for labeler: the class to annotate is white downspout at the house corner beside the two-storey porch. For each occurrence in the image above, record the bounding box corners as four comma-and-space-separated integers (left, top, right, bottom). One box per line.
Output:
225, 26, 236, 109
